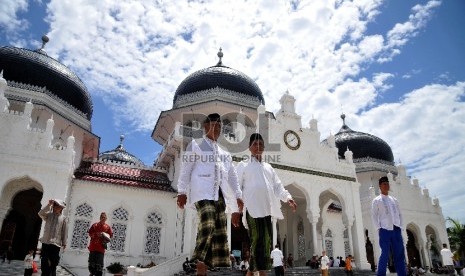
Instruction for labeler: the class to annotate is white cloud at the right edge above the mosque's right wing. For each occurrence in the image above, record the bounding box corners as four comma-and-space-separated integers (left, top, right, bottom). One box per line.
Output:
354, 82, 465, 221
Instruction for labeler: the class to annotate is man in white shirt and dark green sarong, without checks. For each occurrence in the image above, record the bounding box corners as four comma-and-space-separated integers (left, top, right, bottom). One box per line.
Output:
237, 133, 297, 276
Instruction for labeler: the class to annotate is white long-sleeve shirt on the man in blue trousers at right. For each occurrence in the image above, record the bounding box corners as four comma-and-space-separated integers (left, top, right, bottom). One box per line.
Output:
371, 194, 402, 230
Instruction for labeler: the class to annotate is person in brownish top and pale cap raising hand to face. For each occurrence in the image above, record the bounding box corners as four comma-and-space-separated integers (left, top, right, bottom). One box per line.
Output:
39, 199, 68, 276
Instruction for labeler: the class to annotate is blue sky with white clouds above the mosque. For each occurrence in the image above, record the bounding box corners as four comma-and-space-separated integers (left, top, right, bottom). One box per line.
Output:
0, 0, 465, 223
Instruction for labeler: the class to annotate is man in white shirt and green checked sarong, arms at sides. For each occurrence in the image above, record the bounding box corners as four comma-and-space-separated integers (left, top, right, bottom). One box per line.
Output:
177, 113, 243, 275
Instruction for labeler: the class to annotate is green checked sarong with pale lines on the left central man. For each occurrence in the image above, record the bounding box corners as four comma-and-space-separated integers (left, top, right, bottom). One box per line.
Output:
192, 196, 231, 267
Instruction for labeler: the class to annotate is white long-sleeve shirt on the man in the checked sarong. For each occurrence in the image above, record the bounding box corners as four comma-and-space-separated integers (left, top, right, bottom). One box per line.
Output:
178, 136, 242, 212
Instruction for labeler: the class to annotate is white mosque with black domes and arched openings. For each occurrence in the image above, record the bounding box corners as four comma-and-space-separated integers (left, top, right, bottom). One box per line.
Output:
0, 37, 448, 275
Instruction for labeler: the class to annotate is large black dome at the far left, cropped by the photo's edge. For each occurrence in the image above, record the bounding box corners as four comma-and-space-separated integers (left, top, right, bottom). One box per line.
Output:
0, 46, 92, 120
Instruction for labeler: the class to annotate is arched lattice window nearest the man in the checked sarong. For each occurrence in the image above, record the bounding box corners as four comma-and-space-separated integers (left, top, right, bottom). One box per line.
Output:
144, 211, 163, 254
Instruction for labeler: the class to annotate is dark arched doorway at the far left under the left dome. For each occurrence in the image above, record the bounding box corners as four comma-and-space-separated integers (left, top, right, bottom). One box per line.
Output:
0, 188, 42, 260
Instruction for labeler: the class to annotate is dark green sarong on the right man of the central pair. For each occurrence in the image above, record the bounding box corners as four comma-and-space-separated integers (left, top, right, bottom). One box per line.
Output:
246, 212, 273, 271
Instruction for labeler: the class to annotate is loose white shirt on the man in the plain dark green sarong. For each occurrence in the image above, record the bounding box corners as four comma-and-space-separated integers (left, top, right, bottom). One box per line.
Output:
236, 157, 292, 219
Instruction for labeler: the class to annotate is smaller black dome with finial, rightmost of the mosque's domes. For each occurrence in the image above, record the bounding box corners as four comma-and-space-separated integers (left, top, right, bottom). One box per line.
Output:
334, 115, 394, 163
